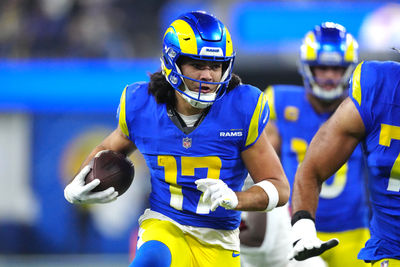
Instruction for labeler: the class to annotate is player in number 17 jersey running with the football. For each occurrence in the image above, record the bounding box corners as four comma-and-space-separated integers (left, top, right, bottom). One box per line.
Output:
65, 12, 290, 266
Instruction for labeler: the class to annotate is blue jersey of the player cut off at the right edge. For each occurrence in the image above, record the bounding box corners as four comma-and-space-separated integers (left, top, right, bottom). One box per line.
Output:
350, 61, 400, 260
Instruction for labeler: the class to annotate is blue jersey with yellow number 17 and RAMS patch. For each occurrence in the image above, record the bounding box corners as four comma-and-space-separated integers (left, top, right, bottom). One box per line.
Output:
118, 83, 269, 230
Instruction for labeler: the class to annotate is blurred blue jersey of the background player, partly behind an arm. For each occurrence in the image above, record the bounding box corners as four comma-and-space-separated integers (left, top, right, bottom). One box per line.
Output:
267, 85, 368, 232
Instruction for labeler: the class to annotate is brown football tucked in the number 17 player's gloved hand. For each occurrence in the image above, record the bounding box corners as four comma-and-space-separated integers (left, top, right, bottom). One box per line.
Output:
85, 150, 135, 196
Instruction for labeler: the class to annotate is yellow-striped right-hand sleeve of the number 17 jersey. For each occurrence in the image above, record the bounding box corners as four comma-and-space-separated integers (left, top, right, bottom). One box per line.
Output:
245, 89, 270, 149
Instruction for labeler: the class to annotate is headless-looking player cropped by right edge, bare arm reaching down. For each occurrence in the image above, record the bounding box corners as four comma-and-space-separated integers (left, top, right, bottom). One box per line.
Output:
292, 55, 400, 267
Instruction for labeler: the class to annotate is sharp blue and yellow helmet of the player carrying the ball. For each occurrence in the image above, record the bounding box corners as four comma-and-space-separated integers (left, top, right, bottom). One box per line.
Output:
161, 11, 235, 108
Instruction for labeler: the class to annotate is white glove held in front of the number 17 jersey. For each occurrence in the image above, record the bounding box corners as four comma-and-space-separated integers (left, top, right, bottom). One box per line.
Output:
195, 178, 238, 211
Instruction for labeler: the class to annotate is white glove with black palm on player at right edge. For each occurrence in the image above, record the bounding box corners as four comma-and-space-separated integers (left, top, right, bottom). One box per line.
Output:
289, 219, 339, 261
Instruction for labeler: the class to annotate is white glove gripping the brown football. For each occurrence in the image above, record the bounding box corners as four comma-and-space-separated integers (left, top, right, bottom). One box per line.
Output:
64, 165, 118, 204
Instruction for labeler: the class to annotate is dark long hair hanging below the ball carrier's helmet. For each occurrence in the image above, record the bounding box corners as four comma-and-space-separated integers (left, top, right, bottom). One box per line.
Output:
149, 71, 242, 106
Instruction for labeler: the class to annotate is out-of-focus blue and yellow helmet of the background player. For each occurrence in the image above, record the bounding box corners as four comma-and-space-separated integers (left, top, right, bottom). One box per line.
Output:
299, 22, 358, 101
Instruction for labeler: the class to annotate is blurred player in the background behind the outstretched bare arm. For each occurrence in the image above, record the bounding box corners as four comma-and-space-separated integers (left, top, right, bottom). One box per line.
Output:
241, 22, 369, 267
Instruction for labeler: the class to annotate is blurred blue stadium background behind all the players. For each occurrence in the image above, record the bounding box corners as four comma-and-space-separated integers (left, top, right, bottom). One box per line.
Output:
0, 0, 400, 266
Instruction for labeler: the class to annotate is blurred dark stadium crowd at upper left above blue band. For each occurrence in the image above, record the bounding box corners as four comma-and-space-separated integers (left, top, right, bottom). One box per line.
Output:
0, 0, 166, 59
